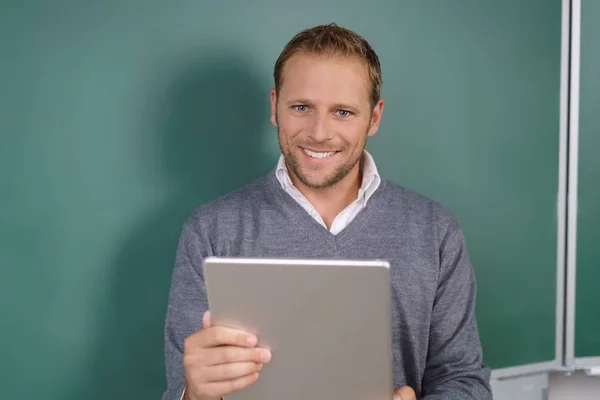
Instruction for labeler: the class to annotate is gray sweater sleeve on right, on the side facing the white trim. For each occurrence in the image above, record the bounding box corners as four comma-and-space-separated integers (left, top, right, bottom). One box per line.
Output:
422, 219, 492, 400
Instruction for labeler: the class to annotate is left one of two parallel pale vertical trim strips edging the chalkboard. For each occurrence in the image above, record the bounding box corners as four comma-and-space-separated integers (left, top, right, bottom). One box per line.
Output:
555, 0, 571, 364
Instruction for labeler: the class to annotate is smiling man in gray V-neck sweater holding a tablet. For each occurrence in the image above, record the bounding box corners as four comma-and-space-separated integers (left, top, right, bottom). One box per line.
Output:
163, 24, 492, 400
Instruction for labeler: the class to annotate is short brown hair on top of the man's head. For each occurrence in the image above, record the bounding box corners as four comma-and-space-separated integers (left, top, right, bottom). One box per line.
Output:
273, 23, 383, 107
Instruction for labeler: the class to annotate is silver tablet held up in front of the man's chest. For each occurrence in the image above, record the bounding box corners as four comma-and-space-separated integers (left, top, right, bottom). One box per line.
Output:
204, 258, 393, 400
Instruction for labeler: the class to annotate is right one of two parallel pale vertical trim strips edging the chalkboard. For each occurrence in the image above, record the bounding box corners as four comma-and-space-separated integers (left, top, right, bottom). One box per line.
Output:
565, 0, 581, 367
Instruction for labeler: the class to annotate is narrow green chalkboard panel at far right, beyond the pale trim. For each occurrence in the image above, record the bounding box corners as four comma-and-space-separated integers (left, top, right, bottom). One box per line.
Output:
575, 0, 600, 358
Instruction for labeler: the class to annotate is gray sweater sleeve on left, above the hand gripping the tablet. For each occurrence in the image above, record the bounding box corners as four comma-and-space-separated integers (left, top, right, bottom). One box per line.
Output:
162, 220, 212, 400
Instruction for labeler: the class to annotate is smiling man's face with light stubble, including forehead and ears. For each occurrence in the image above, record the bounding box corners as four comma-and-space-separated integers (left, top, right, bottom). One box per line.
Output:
271, 53, 383, 189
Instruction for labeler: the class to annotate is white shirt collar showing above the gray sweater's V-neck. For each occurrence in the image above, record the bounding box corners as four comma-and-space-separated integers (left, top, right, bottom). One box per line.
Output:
275, 150, 381, 235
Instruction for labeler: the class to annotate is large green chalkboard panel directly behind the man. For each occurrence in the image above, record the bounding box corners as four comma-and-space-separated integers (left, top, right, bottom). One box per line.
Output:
0, 0, 564, 400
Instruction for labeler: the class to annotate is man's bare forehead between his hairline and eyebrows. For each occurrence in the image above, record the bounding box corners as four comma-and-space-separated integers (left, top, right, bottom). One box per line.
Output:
280, 52, 370, 103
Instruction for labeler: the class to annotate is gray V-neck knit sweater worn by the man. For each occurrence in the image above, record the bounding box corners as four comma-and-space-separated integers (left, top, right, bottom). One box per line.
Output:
163, 171, 492, 400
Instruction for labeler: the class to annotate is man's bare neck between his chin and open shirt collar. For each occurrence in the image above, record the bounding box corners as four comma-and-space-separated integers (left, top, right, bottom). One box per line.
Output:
291, 159, 364, 229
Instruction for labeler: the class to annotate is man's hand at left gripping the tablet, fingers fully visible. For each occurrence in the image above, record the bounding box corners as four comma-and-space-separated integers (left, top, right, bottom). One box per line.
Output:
183, 311, 271, 400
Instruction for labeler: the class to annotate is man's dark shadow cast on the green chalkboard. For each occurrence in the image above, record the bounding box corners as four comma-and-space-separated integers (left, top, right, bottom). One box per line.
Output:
69, 53, 276, 400
